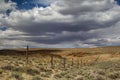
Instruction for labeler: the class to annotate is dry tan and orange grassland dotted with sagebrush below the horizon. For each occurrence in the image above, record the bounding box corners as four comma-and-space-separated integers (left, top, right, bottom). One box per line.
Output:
0, 46, 120, 80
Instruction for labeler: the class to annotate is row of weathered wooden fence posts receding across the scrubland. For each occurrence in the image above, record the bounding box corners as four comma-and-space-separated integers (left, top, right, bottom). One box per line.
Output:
25, 45, 100, 71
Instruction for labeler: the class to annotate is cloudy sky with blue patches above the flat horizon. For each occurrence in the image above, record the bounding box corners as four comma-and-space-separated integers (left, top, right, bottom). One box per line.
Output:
0, 0, 120, 49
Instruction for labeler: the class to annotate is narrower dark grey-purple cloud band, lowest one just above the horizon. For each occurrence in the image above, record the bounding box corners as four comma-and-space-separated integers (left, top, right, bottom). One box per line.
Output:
15, 32, 98, 44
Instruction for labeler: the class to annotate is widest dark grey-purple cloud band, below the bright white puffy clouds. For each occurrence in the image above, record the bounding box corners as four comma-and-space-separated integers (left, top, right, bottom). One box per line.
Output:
8, 13, 120, 35
